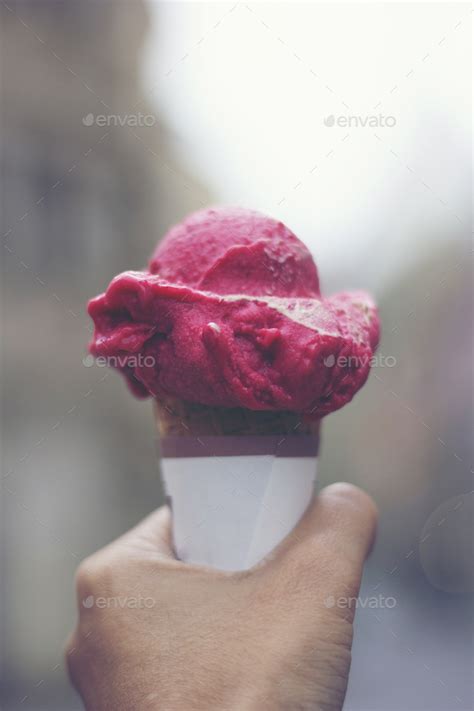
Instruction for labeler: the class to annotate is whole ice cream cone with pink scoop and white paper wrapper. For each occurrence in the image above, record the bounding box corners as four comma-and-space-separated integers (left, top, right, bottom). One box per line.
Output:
88, 207, 380, 570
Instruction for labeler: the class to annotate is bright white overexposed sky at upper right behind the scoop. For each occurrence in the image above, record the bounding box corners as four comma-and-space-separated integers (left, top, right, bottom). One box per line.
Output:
144, 0, 471, 289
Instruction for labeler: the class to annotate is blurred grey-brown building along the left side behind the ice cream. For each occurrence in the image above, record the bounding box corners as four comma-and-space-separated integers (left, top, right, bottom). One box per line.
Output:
0, 0, 209, 710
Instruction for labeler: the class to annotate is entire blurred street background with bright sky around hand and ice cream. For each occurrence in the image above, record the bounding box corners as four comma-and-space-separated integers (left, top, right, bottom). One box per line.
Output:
0, 0, 473, 711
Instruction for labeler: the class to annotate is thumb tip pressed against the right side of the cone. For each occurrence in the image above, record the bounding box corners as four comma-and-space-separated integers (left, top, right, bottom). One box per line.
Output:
266, 483, 377, 594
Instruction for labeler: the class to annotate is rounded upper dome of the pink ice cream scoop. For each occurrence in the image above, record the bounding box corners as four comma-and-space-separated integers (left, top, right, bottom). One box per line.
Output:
149, 208, 319, 296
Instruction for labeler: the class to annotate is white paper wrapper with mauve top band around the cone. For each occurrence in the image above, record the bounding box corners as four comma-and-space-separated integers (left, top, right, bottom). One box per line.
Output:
161, 437, 317, 571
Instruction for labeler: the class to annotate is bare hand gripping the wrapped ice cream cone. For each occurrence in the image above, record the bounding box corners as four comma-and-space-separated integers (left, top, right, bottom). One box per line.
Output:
67, 484, 376, 711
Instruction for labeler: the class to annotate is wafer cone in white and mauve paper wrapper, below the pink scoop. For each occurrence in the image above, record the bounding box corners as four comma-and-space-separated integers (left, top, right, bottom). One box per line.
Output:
155, 399, 319, 570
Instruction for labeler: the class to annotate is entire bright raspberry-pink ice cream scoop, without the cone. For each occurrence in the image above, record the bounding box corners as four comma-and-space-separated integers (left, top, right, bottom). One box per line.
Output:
89, 208, 379, 419
